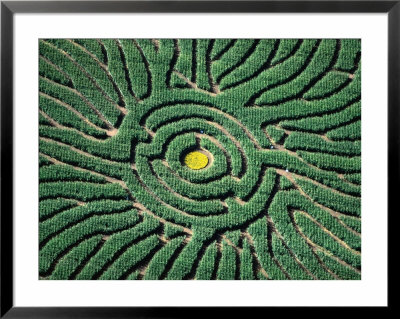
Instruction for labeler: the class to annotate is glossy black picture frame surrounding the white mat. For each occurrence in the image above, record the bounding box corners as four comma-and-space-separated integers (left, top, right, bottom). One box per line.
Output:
0, 0, 394, 318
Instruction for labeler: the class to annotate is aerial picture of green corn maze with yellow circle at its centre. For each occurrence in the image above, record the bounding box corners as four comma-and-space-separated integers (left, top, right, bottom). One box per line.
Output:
39, 39, 361, 280
